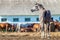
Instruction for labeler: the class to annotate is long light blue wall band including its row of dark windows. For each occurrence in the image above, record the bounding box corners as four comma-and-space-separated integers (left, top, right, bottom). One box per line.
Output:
0, 15, 60, 24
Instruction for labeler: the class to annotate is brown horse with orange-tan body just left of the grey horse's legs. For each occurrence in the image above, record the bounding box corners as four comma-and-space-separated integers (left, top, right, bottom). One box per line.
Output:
21, 23, 41, 32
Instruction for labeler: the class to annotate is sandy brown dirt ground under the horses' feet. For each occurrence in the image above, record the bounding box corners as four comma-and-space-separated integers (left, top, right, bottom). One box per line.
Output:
0, 32, 60, 40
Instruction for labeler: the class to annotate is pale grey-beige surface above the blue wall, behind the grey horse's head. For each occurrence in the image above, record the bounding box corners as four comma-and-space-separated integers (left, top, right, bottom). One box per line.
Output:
0, 0, 60, 15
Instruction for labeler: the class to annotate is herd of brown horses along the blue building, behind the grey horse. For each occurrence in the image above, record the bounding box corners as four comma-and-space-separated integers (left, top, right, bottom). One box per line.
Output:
0, 22, 60, 32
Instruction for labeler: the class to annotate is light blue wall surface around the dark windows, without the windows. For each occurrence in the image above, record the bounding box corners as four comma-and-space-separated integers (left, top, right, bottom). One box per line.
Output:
0, 15, 60, 22
